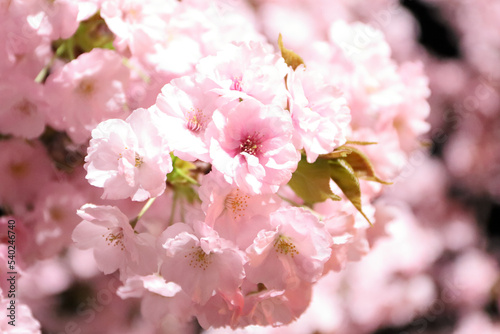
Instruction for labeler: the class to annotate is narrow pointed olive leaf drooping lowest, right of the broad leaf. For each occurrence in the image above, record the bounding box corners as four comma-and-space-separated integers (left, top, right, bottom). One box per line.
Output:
328, 159, 372, 225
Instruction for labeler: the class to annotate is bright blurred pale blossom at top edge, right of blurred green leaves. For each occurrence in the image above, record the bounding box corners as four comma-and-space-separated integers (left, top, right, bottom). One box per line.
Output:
101, 0, 206, 76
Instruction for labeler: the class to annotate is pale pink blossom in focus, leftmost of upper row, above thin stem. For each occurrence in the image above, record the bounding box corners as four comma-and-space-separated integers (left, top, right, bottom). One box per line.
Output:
85, 109, 173, 201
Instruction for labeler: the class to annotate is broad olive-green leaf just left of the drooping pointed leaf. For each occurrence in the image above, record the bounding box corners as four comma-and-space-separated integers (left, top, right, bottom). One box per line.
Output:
288, 156, 341, 204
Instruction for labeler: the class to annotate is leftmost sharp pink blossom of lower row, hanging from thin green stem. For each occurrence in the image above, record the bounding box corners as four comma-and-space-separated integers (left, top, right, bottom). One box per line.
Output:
72, 204, 157, 277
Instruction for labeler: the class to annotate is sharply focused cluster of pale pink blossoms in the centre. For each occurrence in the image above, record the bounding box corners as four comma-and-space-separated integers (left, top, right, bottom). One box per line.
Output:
73, 37, 350, 327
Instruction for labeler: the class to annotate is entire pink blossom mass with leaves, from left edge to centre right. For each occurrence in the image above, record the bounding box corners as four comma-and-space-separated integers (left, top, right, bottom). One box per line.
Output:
0, 0, 429, 333
